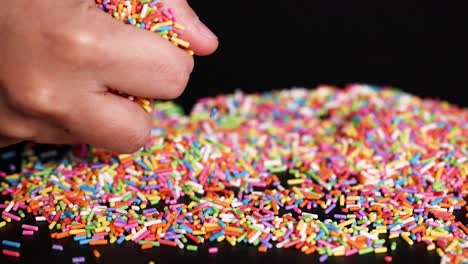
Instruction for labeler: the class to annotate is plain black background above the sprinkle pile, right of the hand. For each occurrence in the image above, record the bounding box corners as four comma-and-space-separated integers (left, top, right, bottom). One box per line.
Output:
179, 0, 468, 109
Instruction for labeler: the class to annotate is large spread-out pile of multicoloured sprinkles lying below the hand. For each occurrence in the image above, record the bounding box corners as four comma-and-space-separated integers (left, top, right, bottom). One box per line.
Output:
0, 84, 468, 263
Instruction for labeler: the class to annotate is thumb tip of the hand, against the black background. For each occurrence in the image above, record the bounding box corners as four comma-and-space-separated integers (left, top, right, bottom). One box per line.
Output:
164, 0, 218, 55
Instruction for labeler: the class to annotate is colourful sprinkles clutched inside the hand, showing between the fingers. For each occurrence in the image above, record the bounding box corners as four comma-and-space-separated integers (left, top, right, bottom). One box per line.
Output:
96, 0, 194, 112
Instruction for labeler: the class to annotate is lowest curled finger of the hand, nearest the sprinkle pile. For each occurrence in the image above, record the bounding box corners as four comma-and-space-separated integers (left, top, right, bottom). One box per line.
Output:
63, 92, 151, 153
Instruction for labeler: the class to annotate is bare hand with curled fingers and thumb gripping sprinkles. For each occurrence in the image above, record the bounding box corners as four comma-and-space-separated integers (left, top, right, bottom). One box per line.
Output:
0, 0, 218, 153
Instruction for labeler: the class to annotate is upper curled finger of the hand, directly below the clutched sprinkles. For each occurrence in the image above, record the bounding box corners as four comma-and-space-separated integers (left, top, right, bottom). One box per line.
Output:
90, 10, 194, 99
